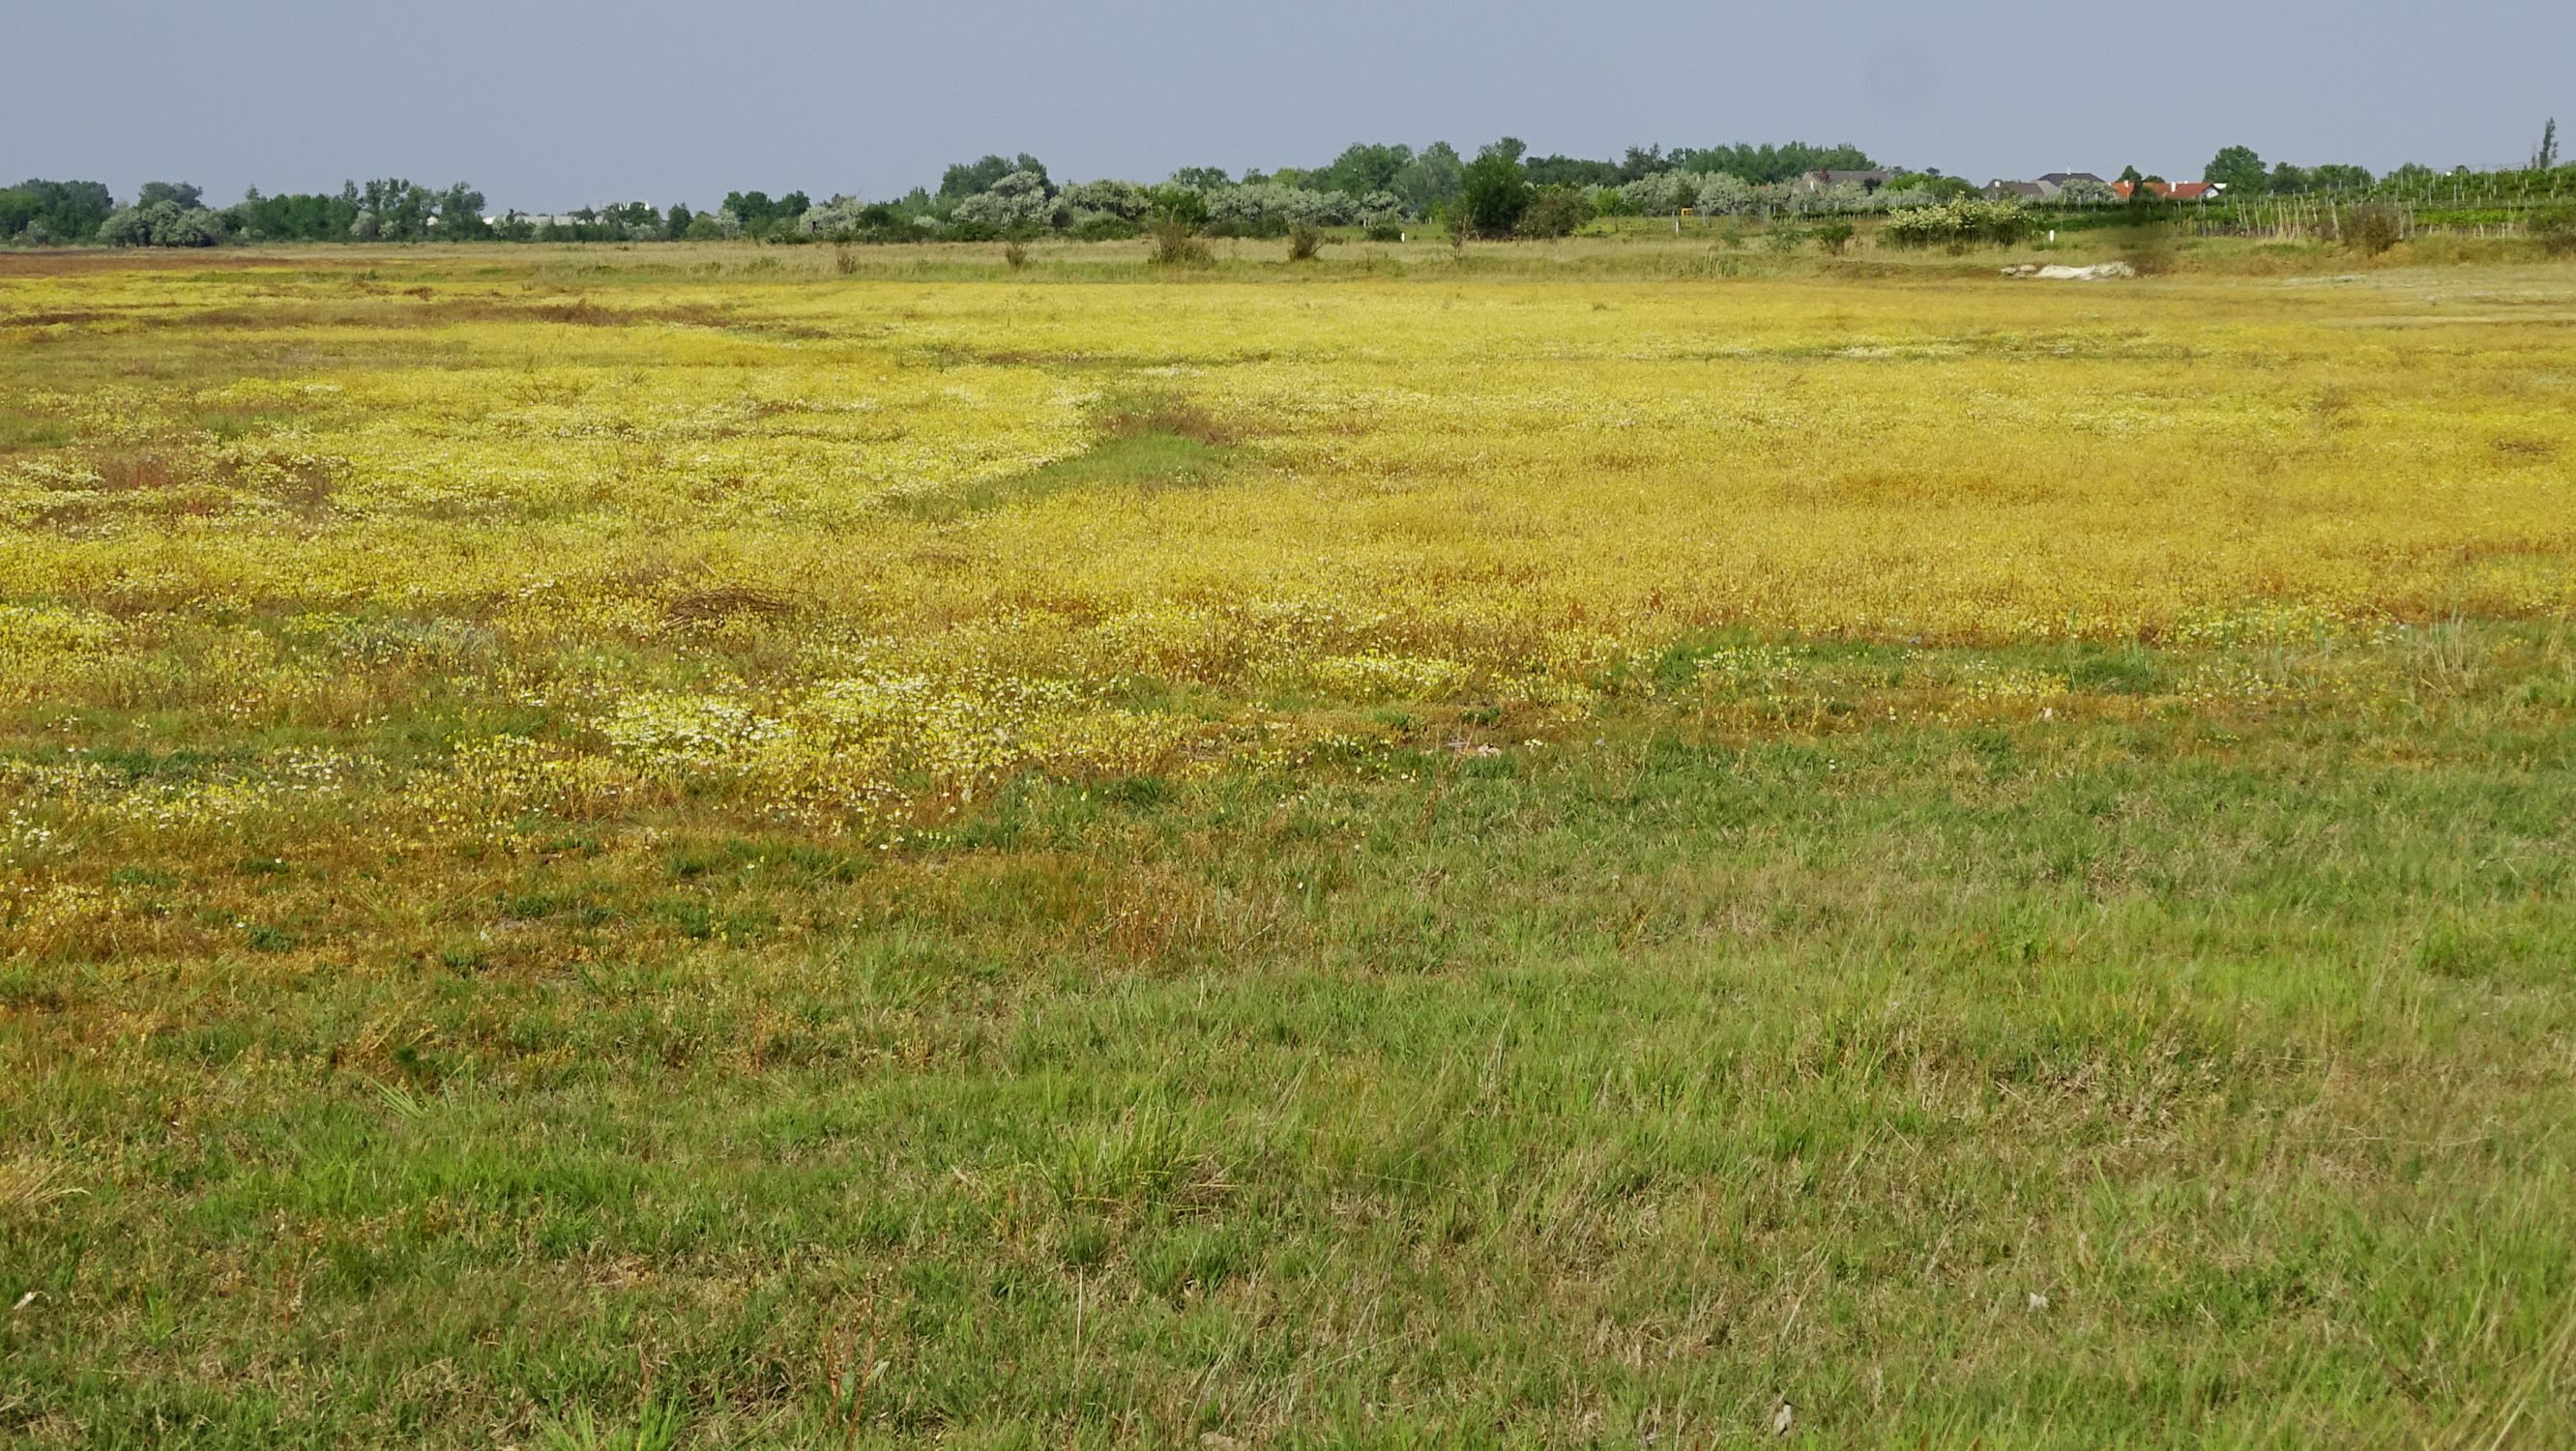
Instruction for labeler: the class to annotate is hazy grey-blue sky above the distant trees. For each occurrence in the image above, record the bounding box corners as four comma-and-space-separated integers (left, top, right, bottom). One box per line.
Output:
0, 0, 2576, 209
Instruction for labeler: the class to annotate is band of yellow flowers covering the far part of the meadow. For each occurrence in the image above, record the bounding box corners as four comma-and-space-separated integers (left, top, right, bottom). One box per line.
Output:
0, 258, 2576, 856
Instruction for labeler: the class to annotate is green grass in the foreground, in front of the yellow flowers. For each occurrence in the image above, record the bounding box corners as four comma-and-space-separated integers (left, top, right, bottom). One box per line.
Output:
0, 624, 2576, 1446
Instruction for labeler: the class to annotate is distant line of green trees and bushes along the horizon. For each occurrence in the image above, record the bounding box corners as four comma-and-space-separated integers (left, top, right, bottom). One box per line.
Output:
19, 121, 2576, 247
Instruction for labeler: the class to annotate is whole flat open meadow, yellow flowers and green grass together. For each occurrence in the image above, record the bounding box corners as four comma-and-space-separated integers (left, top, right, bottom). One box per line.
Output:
0, 240, 2576, 1448
